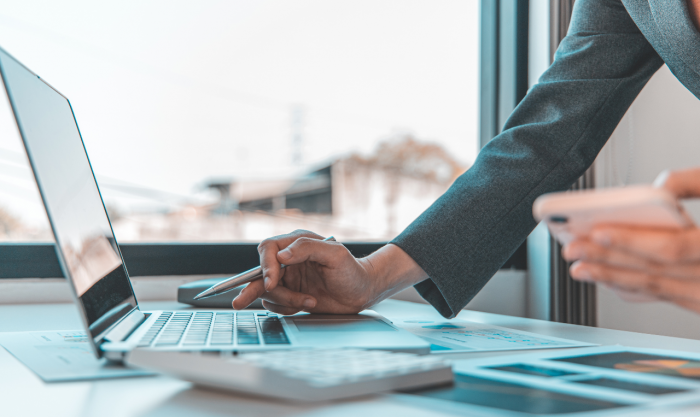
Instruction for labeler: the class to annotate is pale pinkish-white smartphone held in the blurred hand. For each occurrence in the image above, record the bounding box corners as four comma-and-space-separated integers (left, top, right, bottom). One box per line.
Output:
532, 185, 693, 244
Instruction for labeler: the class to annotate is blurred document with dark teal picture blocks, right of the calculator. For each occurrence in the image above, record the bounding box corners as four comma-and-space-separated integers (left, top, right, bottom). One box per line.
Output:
396, 346, 700, 416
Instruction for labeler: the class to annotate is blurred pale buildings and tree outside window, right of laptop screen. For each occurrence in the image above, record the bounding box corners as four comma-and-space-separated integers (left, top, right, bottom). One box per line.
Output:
113, 139, 465, 242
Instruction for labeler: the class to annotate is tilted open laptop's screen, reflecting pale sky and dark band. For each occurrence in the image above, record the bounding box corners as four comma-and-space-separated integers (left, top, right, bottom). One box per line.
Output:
0, 49, 136, 352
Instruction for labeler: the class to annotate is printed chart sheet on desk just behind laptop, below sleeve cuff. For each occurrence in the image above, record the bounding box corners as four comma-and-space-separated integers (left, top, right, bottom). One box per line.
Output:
394, 319, 595, 352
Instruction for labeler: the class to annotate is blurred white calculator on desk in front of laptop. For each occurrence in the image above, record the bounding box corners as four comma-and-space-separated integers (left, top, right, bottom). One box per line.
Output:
126, 348, 453, 402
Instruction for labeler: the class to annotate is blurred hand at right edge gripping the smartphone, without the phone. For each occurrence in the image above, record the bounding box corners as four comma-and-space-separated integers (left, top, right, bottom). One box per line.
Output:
562, 169, 700, 313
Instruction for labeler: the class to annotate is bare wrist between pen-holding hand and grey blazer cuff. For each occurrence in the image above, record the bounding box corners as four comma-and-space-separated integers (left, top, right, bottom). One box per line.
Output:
360, 244, 428, 306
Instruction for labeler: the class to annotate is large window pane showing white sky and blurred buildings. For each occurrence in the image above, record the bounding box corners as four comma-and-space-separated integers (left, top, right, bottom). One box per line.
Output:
0, 0, 479, 242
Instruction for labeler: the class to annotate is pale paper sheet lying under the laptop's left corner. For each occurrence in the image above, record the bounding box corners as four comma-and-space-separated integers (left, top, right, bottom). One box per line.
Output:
0, 330, 153, 382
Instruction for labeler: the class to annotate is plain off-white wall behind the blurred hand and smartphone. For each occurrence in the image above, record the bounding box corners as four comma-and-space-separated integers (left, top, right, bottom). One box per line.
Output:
596, 66, 700, 339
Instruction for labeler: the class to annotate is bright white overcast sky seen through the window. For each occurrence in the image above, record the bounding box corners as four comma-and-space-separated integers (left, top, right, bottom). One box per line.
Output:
0, 0, 478, 228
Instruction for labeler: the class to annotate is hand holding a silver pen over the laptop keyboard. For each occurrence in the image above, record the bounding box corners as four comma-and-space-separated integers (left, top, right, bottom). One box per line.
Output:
232, 230, 427, 314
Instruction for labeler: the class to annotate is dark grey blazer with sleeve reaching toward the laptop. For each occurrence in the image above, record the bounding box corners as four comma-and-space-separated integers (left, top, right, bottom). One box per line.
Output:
392, 0, 700, 318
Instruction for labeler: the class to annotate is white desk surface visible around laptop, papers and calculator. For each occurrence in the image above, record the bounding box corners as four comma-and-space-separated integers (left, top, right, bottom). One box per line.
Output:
0, 300, 700, 417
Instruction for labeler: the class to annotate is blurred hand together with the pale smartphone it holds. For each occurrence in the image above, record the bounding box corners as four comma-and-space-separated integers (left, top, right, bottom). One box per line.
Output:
533, 168, 700, 313
